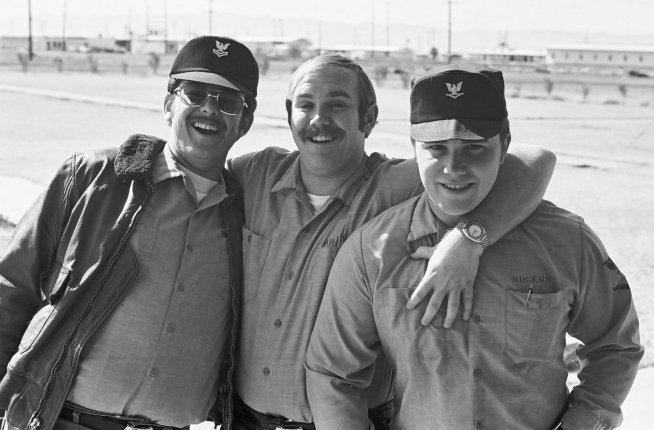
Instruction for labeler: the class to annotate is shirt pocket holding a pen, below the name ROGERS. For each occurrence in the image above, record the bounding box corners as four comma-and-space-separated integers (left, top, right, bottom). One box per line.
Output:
506, 290, 569, 361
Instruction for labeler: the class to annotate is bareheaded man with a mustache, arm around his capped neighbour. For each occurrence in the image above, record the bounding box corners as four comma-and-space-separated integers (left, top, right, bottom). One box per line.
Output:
228, 55, 554, 430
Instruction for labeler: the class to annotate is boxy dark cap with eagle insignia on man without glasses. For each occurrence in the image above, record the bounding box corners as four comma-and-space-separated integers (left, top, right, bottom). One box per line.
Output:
411, 63, 508, 142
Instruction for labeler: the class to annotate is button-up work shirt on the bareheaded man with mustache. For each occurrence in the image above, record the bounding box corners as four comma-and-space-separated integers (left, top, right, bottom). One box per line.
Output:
230, 148, 422, 422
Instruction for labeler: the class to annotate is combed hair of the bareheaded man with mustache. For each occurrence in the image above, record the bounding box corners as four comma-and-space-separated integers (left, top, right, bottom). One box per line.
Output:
286, 54, 377, 137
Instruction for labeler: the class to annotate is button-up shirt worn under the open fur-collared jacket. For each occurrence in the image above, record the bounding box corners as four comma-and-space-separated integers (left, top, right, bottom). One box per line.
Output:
68, 146, 230, 427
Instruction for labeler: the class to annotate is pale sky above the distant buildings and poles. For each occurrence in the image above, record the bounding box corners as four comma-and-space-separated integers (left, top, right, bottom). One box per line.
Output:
0, 0, 654, 49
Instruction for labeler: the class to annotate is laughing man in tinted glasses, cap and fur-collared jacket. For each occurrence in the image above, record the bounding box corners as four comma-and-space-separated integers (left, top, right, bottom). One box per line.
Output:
0, 37, 259, 430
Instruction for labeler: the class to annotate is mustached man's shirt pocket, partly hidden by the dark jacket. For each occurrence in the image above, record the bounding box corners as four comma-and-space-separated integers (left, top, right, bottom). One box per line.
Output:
243, 226, 271, 303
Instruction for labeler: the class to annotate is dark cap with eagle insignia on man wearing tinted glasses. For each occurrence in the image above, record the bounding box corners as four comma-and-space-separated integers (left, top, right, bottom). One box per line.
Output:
170, 36, 259, 97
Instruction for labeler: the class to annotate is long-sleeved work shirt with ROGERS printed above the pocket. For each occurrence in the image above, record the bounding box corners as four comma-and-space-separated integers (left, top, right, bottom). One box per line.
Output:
306, 195, 643, 430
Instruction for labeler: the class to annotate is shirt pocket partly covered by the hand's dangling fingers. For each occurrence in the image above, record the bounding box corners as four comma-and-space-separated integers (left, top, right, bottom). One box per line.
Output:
375, 288, 447, 362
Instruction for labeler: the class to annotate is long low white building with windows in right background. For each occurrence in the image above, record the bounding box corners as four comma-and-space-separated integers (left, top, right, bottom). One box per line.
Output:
547, 44, 654, 72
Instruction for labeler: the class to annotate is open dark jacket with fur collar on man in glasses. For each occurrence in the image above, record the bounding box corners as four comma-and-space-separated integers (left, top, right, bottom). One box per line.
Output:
0, 135, 243, 430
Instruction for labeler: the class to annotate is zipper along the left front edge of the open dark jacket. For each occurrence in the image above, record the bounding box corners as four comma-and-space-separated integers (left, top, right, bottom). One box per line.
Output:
28, 181, 155, 430
